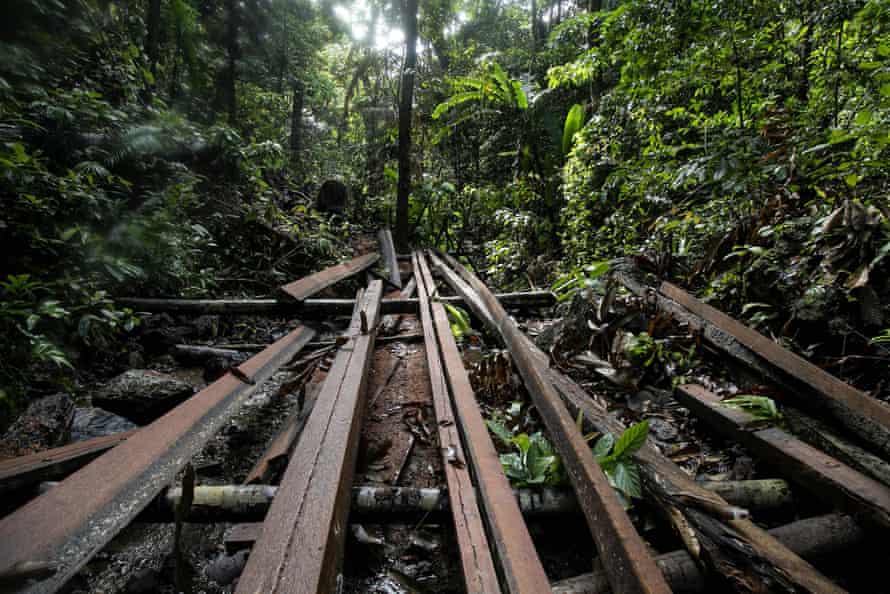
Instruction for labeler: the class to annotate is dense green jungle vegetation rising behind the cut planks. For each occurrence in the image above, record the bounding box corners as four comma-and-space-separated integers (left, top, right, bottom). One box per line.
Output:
0, 0, 890, 423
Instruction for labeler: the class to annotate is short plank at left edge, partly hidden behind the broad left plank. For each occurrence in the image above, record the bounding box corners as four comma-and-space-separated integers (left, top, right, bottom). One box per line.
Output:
0, 429, 138, 494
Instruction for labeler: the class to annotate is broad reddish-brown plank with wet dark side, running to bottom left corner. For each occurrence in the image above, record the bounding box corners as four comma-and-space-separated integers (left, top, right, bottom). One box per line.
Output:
0, 326, 314, 594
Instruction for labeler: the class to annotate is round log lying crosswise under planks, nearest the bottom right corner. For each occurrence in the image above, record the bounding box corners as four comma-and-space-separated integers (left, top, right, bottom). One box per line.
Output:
553, 514, 866, 594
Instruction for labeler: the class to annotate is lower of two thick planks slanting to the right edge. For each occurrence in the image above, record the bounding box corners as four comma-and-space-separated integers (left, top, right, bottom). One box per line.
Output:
675, 384, 890, 528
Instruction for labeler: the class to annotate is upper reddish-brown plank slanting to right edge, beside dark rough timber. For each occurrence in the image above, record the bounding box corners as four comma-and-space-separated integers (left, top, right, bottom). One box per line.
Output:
659, 282, 890, 456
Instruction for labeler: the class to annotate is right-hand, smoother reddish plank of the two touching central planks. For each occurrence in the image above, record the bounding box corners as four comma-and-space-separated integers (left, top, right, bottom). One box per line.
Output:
415, 252, 550, 594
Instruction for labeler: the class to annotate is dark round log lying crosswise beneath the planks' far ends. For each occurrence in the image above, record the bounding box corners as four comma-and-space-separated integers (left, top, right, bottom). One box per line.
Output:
117, 291, 556, 319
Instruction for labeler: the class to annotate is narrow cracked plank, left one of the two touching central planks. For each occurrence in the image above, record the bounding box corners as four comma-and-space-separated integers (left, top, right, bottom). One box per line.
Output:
414, 253, 501, 594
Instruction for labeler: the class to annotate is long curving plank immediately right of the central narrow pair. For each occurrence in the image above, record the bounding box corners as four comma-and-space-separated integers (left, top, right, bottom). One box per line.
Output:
428, 250, 670, 594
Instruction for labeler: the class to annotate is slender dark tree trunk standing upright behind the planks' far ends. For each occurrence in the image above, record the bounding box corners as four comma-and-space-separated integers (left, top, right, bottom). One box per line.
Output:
395, 0, 418, 252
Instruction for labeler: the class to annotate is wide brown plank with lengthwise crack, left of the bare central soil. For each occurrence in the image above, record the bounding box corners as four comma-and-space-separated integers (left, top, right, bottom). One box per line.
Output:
237, 281, 383, 594
